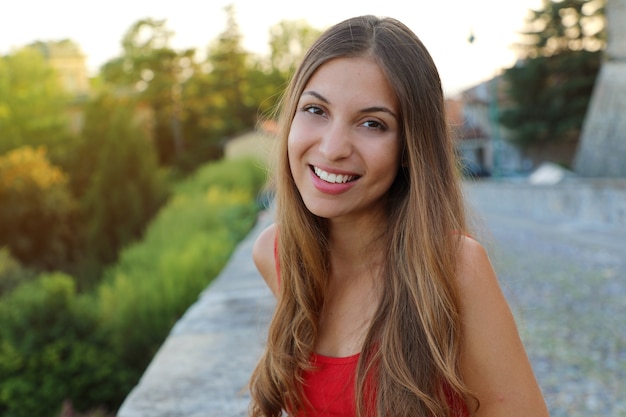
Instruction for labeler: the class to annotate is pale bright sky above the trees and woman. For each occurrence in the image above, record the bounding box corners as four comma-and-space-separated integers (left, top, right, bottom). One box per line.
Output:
0, 0, 541, 95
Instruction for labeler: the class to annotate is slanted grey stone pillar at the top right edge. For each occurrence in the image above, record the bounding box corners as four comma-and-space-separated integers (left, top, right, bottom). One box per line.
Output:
574, 0, 626, 177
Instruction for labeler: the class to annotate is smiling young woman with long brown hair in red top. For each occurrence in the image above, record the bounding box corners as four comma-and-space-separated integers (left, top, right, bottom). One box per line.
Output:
250, 16, 548, 417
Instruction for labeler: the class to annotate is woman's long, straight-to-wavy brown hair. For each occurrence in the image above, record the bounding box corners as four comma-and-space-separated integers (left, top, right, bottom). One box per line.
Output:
250, 16, 471, 417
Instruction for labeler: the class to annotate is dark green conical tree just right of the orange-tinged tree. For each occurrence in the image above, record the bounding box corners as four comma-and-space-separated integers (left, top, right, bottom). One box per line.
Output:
71, 93, 167, 285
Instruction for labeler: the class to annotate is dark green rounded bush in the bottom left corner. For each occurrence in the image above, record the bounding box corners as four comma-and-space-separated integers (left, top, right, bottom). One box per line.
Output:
0, 273, 132, 417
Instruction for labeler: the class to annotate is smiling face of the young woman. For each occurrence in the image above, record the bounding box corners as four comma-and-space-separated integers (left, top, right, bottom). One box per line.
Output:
288, 58, 401, 224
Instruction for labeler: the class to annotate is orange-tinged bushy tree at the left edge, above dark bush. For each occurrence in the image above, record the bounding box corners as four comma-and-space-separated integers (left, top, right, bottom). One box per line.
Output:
0, 146, 78, 270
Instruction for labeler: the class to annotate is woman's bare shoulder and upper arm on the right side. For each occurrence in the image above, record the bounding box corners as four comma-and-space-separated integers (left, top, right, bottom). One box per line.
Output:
457, 237, 548, 417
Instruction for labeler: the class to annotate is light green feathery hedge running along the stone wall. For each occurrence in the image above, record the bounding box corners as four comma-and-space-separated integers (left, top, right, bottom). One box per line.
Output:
98, 155, 265, 377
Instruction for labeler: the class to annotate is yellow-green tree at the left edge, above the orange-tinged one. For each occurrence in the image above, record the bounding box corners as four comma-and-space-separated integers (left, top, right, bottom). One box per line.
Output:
0, 47, 69, 154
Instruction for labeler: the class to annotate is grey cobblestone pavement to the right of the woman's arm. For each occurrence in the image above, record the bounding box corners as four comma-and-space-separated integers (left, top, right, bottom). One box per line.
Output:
468, 202, 626, 417
